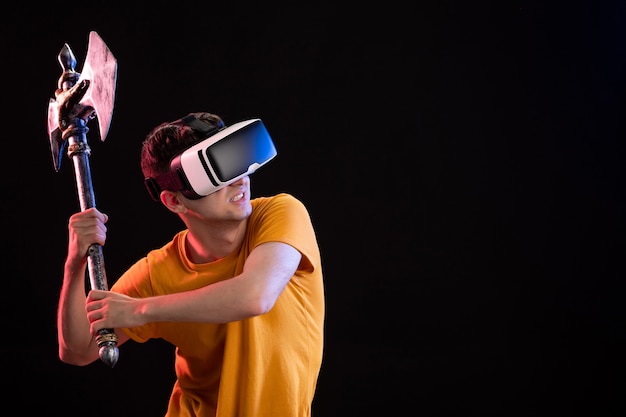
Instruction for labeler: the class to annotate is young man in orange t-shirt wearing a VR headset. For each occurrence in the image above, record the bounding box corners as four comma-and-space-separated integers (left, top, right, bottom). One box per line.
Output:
57, 113, 324, 417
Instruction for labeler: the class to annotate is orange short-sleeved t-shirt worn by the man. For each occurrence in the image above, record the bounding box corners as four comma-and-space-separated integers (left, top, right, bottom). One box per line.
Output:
111, 193, 325, 417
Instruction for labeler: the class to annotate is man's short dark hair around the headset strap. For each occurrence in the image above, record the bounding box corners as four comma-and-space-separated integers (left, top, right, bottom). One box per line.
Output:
141, 112, 224, 178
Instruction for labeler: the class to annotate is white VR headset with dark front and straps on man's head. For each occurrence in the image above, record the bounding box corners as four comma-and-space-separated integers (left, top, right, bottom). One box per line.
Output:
144, 114, 277, 201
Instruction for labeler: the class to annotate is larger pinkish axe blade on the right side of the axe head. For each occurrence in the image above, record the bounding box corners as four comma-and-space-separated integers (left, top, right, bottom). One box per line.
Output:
78, 31, 117, 142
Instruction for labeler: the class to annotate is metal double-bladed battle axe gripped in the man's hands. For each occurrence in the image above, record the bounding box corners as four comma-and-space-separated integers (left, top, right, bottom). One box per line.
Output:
48, 31, 119, 367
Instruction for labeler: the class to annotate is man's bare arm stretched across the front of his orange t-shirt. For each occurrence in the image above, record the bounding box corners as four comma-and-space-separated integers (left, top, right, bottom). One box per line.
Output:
87, 242, 302, 334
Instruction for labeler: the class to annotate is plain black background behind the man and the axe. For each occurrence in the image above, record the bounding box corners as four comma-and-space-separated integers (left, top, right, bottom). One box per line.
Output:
0, 1, 626, 417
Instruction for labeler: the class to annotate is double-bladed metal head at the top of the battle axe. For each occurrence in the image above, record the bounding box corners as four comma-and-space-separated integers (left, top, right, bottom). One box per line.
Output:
48, 31, 117, 171
